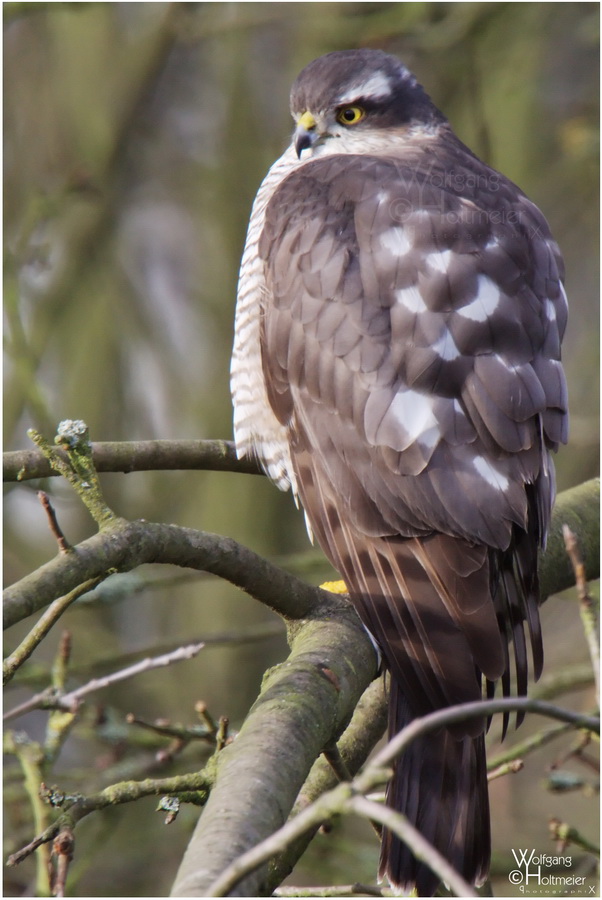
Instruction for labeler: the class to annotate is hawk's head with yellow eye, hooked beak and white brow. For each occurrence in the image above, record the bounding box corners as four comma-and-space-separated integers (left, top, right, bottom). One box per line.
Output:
291, 49, 445, 157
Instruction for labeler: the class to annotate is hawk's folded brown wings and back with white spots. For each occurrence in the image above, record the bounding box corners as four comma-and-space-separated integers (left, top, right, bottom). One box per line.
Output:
255, 138, 566, 733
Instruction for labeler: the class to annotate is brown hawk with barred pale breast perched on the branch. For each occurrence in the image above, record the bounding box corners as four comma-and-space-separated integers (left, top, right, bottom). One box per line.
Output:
231, 49, 567, 895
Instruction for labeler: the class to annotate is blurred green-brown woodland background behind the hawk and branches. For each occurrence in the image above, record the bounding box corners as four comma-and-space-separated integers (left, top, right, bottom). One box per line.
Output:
3, 2, 599, 896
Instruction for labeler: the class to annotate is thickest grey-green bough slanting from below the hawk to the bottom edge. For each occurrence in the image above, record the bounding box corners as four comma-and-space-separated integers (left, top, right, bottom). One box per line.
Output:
172, 609, 376, 897
